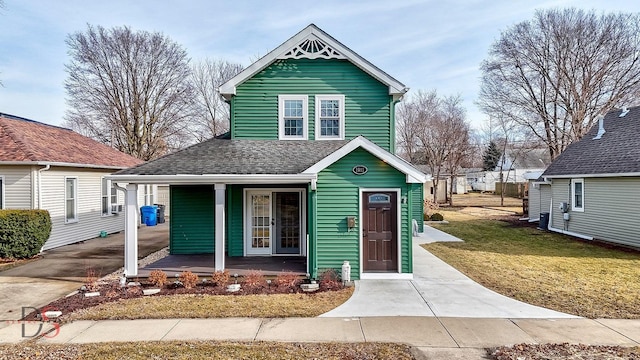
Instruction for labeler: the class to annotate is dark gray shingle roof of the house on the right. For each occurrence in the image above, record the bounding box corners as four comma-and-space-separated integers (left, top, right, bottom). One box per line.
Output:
542, 107, 640, 177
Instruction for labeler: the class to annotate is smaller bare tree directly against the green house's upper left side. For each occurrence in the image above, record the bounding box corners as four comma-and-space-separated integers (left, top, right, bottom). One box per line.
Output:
190, 59, 243, 141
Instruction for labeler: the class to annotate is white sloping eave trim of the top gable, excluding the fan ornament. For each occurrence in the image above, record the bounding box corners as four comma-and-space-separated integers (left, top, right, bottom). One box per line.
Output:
219, 24, 409, 100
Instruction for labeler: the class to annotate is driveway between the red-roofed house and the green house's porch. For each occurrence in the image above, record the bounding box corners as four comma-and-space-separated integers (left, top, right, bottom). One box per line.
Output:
0, 223, 169, 320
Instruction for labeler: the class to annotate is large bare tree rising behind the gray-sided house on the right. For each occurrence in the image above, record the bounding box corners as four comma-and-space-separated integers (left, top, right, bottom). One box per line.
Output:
478, 8, 640, 160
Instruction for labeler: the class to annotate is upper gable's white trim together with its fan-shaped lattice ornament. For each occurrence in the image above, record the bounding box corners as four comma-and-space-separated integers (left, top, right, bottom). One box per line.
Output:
220, 24, 408, 100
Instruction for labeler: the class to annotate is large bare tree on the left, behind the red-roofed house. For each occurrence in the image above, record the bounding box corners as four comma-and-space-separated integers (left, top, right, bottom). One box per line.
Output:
65, 25, 193, 160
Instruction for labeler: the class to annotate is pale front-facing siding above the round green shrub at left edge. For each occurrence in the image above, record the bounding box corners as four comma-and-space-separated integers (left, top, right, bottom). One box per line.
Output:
0, 166, 32, 209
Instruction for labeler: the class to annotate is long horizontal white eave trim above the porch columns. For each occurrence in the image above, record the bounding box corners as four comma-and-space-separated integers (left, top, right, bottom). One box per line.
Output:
105, 174, 317, 185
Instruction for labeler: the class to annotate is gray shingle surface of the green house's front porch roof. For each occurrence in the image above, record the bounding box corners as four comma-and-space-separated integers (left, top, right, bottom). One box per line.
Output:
114, 138, 348, 175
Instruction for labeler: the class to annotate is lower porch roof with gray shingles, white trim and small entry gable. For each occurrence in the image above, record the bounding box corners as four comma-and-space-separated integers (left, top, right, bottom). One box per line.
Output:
111, 136, 426, 184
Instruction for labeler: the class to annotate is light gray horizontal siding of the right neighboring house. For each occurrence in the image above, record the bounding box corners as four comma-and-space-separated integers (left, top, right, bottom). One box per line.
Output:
553, 177, 640, 247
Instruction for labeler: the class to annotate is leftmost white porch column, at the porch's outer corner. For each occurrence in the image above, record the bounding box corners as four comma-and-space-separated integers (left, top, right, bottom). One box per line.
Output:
124, 184, 139, 276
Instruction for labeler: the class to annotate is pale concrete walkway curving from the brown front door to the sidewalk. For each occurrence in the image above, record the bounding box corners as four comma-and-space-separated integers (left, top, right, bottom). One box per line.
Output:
321, 226, 576, 319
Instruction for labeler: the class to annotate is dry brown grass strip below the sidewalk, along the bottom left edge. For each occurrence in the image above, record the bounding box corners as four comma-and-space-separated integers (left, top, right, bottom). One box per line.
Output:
0, 341, 413, 360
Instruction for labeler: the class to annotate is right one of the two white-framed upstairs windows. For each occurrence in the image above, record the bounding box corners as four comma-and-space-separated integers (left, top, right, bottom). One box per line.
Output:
316, 95, 344, 140
